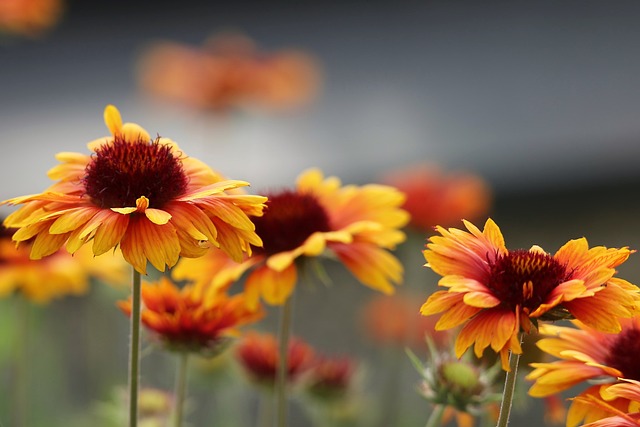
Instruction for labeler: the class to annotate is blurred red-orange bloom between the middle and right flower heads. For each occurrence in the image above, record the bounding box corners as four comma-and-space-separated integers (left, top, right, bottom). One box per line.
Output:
382, 164, 491, 232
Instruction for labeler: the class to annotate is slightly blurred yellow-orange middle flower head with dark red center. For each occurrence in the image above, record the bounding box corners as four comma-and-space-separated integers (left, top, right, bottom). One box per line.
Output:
174, 169, 408, 305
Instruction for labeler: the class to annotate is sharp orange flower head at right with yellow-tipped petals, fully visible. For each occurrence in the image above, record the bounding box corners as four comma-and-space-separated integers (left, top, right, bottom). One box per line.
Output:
421, 219, 640, 370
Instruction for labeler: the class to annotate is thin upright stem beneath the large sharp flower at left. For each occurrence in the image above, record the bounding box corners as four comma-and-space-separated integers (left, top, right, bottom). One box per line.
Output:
129, 268, 141, 427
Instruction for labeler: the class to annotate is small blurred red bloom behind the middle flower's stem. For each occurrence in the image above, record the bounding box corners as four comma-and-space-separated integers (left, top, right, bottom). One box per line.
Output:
236, 332, 315, 387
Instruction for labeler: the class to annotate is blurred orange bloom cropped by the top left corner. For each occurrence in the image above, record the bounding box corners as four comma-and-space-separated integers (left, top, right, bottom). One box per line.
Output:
0, 0, 64, 37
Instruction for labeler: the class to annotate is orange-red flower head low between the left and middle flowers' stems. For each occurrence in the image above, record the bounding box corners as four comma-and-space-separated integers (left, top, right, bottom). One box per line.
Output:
118, 277, 264, 355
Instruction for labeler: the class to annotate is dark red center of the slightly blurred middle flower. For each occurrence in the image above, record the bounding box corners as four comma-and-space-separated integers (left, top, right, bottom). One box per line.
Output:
252, 190, 331, 255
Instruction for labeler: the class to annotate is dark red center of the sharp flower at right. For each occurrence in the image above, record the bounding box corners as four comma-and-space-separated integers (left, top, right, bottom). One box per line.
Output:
488, 249, 568, 311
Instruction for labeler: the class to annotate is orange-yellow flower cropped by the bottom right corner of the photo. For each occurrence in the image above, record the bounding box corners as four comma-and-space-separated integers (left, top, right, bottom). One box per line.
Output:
527, 316, 640, 426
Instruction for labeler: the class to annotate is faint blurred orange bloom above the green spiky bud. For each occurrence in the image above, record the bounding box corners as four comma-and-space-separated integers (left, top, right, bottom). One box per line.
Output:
362, 294, 451, 349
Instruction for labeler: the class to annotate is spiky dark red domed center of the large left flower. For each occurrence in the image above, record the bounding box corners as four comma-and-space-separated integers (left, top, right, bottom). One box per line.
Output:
84, 136, 188, 208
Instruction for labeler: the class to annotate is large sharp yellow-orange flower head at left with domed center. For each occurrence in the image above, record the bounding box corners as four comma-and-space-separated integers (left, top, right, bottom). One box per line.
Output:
3, 105, 266, 274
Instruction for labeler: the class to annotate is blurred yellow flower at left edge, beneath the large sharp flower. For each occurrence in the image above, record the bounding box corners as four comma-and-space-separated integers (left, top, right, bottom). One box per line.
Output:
0, 222, 130, 304
